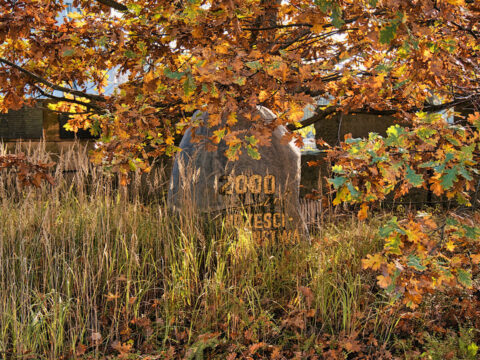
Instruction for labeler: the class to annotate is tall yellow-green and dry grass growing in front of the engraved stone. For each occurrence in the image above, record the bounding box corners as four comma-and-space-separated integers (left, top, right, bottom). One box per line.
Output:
0, 140, 396, 359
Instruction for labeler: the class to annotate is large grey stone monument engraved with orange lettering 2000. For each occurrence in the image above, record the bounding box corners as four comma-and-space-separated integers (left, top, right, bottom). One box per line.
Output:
168, 106, 307, 242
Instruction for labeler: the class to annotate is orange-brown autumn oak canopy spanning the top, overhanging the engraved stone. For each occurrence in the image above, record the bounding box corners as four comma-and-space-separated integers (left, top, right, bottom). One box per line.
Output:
0, 0, 480, 171
